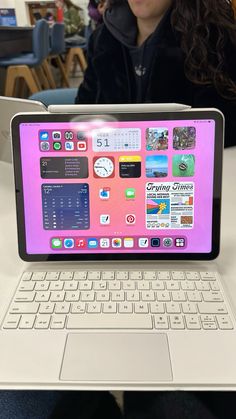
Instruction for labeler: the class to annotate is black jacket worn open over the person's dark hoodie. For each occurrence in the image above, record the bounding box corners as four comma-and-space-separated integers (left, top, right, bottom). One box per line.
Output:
76, 15, 236, 147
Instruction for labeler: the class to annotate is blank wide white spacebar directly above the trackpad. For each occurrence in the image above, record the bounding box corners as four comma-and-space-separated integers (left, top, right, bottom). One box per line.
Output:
67, 314, 152, 329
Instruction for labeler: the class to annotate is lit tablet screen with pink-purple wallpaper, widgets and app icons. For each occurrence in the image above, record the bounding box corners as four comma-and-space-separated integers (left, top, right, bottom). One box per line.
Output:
20, 120, 215, 254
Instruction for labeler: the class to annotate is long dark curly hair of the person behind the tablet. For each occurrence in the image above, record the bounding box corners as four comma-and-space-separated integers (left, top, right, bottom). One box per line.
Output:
109, 0, 236, 99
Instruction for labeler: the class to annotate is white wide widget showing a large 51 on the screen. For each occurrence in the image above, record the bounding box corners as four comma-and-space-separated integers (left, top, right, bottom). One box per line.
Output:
92, 128, 141, 153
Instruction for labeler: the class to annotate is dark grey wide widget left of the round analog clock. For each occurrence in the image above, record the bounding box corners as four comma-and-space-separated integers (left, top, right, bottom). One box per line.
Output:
40, 157, 88, 179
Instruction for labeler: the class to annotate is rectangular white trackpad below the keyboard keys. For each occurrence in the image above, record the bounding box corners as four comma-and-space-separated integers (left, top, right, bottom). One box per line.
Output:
60, 333, 172, 383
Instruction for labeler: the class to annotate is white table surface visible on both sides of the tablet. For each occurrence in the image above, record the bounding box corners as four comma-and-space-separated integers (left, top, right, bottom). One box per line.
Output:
0, 147, 236, 390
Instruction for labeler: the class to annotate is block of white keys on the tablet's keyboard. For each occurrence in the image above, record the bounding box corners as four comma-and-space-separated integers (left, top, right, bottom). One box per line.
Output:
2, 270, 234, 330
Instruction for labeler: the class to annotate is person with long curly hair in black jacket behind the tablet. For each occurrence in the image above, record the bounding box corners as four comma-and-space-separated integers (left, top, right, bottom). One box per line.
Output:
76, 0, 236, 146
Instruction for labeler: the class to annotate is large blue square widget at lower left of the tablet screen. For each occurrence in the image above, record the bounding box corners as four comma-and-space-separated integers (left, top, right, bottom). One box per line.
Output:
42, 183, 90, 230
